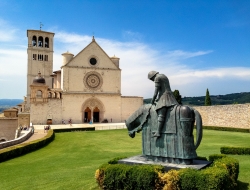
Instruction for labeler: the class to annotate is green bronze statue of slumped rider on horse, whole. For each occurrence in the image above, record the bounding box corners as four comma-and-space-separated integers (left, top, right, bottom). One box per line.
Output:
125, 71, 202, 164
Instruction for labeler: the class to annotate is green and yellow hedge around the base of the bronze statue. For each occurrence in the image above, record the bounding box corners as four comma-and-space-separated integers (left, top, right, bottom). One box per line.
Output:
95, 155, 239, 190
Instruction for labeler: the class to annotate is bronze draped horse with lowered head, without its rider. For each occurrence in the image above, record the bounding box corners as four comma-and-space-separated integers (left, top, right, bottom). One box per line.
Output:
125, 104, 202, 164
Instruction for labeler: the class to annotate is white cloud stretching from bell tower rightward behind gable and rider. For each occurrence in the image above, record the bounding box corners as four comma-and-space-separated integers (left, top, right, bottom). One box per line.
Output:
49, 32, 250, 98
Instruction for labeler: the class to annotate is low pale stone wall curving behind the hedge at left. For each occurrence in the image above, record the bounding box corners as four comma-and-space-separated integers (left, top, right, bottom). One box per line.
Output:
0, 127, 34, 149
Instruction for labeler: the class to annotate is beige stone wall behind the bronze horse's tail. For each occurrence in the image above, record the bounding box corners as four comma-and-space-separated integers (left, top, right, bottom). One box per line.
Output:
193, 104, 250, 128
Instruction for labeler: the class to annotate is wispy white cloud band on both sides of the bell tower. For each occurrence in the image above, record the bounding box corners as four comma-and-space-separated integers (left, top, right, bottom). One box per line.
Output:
0, 31, 250, 98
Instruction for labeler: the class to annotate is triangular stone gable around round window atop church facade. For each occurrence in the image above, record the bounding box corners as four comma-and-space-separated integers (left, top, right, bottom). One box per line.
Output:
65, 38, 119, 69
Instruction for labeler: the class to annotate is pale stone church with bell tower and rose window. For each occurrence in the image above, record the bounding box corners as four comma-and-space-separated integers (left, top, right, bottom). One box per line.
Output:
18, 30, 143, 125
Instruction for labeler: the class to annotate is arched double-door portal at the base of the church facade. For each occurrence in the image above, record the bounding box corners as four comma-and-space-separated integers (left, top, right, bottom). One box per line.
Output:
82, 98, 105, 123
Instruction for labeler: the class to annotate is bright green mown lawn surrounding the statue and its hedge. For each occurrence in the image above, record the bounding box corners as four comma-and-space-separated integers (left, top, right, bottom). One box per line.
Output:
0, 130, 250, 190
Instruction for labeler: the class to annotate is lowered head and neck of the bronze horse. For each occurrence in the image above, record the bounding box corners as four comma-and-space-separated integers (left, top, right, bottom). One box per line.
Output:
125, 104, 151, 138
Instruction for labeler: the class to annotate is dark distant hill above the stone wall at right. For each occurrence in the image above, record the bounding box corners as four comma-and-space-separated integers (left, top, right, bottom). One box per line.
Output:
144, 92, 250, 106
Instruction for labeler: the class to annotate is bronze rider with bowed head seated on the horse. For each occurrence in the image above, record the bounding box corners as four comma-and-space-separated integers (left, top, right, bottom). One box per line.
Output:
148, 71, 179, 138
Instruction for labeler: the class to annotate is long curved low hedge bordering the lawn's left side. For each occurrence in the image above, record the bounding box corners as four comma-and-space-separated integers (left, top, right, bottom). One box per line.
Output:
0, 129, 55, 162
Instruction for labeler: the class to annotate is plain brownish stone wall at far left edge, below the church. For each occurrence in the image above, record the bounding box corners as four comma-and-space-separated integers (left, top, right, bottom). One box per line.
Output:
0, 117, 18, 141
